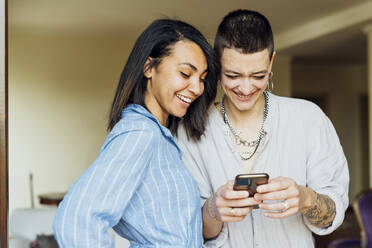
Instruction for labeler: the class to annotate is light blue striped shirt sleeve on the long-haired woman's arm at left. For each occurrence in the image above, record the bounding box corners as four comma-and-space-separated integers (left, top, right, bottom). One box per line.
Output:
54, 123, 156, 248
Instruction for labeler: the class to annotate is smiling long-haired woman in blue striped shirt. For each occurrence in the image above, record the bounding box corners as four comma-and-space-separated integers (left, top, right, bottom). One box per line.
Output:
54, 20, 218, 248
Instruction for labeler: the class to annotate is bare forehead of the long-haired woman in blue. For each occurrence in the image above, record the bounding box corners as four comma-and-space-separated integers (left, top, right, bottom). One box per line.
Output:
164, 40, 207, 72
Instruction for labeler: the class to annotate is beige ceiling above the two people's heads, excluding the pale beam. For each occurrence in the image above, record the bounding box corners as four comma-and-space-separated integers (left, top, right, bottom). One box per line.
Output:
8, 0, 370, 62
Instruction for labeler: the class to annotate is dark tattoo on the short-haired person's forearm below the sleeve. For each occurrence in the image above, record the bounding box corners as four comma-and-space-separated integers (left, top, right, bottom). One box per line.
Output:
303, 192, 336, 228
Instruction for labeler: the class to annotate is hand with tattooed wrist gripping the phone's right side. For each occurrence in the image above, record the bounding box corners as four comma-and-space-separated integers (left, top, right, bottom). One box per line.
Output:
254, 177, 336, 228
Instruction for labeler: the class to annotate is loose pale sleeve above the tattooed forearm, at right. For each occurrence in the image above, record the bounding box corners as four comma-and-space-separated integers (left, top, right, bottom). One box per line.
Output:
303, 110, 349, 235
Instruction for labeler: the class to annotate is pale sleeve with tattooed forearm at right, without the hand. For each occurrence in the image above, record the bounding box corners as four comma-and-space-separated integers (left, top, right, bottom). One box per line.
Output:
303, 113, 349, 235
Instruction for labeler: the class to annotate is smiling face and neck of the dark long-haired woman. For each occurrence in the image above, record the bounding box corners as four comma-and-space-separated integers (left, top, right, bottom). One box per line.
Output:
145, 41, 207, 126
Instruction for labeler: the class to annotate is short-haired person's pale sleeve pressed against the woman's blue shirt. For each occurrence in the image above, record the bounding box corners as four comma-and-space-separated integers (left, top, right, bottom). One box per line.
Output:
176, 126, 228, 248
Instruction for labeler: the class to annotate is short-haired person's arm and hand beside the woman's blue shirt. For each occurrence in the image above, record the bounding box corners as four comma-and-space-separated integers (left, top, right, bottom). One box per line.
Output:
177, 126, 255, 244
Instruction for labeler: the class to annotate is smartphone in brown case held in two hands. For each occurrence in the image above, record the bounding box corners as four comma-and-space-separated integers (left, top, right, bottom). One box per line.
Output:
233, 173, 269, 196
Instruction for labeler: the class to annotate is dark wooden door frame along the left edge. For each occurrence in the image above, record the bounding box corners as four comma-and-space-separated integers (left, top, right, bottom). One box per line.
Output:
0, 0, 9, 248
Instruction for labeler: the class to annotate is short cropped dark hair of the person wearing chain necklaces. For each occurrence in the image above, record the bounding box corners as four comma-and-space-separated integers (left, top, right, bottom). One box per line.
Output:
214, 9, 274, 59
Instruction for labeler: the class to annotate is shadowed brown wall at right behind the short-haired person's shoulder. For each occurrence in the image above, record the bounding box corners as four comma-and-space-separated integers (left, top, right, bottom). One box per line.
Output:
292, 63, 368, 200
